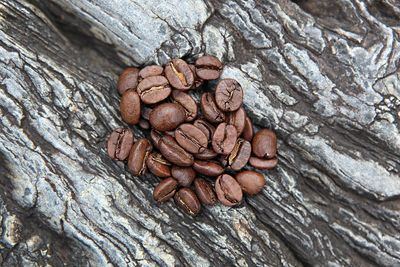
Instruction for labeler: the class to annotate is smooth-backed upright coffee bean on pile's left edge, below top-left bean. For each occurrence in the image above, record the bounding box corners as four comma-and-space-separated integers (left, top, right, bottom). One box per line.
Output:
119, 89, 140, 124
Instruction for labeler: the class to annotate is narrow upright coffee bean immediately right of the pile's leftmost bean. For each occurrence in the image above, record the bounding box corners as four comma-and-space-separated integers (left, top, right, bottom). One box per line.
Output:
128, 138, 152, 176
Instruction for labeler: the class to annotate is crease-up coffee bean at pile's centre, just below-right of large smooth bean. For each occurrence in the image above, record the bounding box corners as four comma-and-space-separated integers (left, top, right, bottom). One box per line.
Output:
175, 123, 208, 153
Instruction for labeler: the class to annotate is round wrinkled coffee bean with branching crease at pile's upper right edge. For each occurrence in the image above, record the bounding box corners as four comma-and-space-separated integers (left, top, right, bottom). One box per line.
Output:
215, 79, 243, 111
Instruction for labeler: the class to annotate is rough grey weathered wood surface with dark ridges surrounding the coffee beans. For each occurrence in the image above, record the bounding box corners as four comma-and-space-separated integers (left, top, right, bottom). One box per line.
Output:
0, 0, 400, 266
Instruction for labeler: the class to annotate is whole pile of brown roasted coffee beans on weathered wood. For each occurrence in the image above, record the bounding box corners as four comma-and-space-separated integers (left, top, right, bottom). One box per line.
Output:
107, 55, 278, 216
